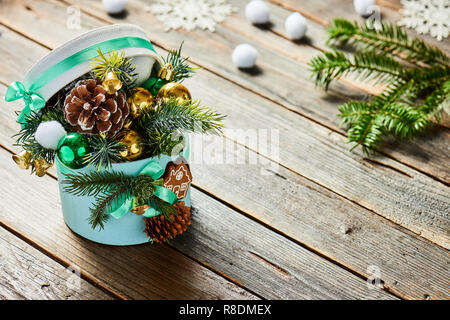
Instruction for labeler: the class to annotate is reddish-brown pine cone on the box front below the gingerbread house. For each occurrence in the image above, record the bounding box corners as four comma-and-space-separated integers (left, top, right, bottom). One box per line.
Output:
144, 201, 191, 243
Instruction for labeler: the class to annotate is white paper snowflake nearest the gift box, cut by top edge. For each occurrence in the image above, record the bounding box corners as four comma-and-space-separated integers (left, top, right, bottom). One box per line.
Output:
146, 0, 236, 32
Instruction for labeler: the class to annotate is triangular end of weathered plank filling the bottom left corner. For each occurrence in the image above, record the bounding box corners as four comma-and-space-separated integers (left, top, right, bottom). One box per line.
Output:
0, 228, 113, 300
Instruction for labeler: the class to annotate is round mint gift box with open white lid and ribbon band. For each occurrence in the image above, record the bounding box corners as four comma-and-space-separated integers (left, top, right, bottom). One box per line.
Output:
10, 24, 190, 245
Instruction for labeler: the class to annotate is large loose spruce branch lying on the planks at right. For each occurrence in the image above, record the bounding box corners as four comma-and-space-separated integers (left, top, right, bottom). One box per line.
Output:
310, 19, 450, 153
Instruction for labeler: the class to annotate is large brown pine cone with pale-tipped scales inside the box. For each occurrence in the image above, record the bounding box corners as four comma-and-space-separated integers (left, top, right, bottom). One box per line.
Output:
64, 79, 130, 137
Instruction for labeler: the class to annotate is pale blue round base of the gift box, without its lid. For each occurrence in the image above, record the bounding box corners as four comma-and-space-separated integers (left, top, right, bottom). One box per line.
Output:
55, 149, 191, 246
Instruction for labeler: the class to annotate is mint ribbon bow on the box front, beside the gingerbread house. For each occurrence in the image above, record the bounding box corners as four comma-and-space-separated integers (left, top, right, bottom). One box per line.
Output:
109, 161, 178, 219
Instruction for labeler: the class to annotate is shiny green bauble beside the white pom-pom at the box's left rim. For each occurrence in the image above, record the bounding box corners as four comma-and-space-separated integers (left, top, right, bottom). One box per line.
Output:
58, 132, 89, 169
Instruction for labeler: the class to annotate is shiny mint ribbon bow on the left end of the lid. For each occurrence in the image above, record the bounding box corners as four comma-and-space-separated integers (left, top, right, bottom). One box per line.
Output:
5, 81, 45, 124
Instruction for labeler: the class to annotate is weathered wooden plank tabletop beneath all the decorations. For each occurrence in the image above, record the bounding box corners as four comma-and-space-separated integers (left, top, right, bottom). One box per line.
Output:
0, 0, 450, 299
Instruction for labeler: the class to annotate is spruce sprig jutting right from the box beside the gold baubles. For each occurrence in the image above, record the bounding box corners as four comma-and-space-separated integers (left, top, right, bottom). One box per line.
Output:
140, 98, 226, 134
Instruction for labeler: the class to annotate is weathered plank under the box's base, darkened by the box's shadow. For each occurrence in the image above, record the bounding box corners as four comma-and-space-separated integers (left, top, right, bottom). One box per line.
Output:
0, 159, 255, 299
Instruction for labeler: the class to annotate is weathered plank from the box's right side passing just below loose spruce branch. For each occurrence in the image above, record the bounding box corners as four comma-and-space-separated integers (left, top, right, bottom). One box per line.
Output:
0, 3, 444, 248
